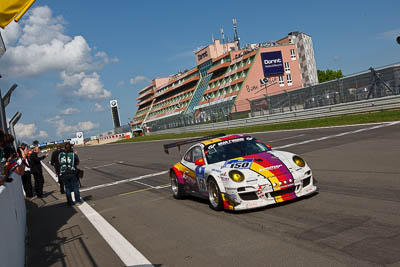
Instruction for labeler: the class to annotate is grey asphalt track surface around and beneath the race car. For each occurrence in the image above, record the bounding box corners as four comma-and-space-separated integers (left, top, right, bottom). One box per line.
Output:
43, 123, 400, 266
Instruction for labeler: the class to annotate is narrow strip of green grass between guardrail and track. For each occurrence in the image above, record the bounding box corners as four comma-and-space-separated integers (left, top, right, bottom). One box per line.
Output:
116, 110, 400, 143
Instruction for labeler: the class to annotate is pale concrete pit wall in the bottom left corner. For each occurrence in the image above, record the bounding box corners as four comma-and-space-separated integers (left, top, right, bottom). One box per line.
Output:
0, 173, 26, 267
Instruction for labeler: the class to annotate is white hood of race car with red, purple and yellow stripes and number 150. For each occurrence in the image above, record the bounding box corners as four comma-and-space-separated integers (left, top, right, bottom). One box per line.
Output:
219, 152, 294, 190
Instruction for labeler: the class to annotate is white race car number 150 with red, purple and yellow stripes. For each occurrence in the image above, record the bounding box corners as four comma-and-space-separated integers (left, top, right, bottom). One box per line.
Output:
164, 134, 317, 210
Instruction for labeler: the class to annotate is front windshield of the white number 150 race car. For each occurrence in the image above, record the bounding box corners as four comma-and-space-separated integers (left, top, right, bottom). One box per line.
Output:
204, 137, 270, 164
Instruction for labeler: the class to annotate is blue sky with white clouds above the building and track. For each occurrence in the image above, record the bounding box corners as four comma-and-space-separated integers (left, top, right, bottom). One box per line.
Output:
0, 0, 400, 143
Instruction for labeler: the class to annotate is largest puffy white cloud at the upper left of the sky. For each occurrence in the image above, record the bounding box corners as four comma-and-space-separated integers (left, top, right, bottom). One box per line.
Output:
0, 6, 105, 77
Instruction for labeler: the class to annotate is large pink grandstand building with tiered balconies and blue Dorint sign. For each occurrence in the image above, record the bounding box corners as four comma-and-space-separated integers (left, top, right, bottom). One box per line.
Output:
131, 32, 318, 130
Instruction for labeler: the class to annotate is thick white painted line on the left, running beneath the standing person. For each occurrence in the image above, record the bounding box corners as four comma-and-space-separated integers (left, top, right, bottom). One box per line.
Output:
42, 163, 153, 266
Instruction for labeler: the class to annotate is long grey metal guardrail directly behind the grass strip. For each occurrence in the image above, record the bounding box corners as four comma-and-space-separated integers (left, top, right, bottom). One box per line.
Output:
153, 95, 400, 134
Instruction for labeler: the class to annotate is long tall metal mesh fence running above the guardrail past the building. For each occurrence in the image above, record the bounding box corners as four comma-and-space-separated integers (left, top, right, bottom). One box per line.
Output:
146, 64, 400, 132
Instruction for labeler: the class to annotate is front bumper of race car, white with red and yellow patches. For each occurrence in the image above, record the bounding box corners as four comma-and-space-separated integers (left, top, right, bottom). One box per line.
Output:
223, 176, 318, 210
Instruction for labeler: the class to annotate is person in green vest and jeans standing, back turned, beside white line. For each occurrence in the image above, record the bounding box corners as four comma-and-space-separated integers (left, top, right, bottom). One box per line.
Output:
58, 143, 83, 206
